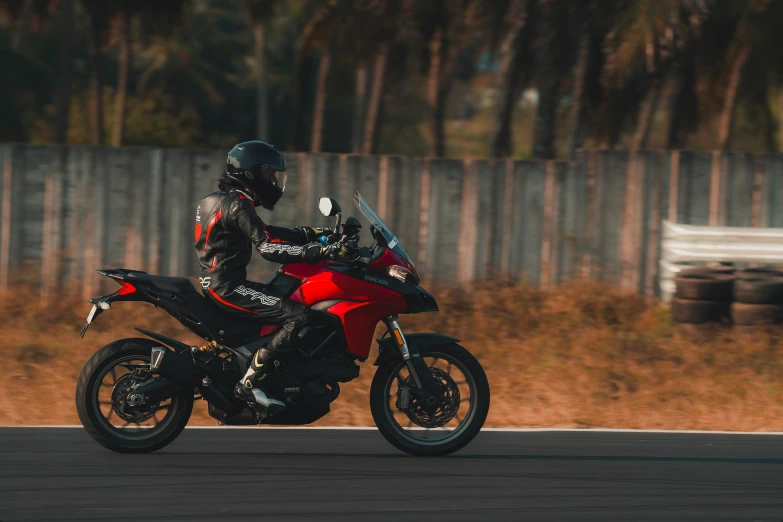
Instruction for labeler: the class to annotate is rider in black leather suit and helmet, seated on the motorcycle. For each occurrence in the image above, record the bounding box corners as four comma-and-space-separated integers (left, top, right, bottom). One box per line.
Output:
196, 141, 345, 409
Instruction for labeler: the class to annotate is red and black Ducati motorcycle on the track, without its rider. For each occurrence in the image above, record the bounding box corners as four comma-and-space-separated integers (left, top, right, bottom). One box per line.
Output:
76, 192, 489, 455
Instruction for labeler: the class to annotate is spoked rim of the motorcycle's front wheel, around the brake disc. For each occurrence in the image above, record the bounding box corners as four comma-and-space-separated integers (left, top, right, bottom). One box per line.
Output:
384, 352, 478, 446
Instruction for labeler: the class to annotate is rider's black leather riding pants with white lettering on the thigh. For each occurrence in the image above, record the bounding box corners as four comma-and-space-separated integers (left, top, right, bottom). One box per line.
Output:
204, 277, 309, 365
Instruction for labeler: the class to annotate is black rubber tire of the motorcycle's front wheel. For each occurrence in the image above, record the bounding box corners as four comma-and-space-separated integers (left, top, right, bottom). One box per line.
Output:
370, 343, 490, 457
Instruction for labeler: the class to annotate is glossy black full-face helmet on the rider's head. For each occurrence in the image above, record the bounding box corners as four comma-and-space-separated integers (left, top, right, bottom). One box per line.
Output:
226, 141, 288, 210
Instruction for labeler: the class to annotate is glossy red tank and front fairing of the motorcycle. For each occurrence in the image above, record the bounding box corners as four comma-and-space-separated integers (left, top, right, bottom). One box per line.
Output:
278, 249, 413, 359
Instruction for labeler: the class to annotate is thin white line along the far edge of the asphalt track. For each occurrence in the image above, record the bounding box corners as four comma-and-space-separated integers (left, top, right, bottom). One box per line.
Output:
0, 424, 783, 436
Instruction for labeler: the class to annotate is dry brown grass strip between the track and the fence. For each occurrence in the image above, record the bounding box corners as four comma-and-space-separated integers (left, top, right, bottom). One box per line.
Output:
0, 281, 783, 431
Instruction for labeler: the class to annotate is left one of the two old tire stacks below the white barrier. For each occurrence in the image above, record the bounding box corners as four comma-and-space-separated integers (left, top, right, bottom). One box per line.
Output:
672, 267, 735, 324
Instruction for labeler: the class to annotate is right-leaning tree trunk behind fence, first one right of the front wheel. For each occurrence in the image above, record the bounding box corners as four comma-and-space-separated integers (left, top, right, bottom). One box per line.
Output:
490, 0, 527, 158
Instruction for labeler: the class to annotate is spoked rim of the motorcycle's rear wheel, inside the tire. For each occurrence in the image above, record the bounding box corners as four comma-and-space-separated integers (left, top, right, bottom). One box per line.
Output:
92, 355, 180, 440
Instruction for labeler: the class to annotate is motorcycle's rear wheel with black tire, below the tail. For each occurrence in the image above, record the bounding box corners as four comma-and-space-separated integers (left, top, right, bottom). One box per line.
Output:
76, 339, 193, 453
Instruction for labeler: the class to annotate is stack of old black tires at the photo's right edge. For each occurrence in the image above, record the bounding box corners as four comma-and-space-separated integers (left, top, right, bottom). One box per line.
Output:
731, 268, 783, 326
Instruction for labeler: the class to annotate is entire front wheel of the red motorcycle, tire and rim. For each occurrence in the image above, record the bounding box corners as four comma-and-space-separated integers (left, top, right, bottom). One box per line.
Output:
370, 344, 489, 456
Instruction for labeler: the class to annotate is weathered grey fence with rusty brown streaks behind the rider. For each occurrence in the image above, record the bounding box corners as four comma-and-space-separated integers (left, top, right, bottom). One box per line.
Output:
0, 144, 783, 295
